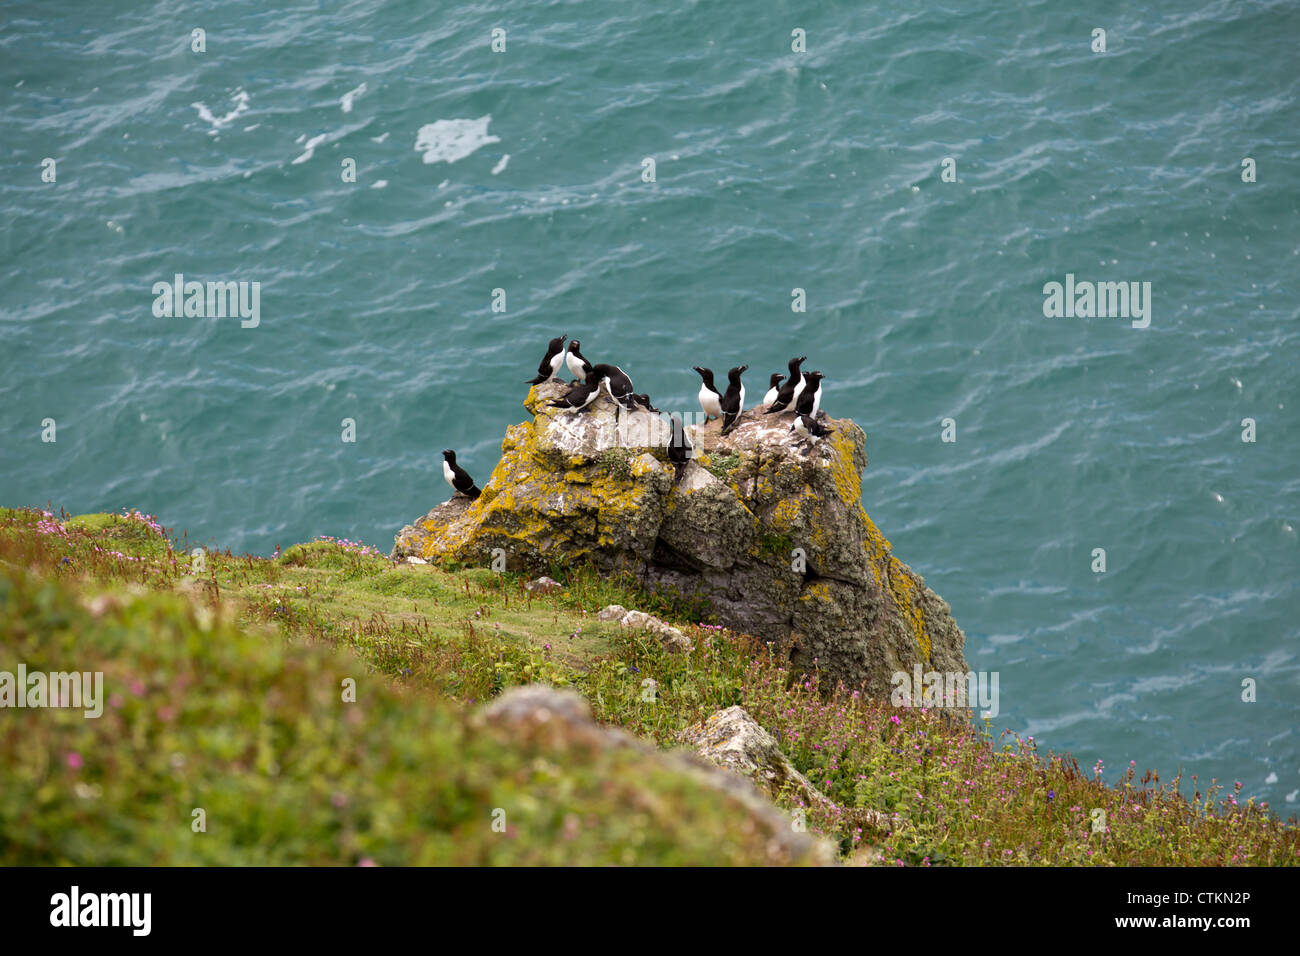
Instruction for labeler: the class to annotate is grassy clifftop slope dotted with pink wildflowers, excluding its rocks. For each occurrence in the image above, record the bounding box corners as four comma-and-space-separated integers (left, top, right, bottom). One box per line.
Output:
0, 511, 1300, 865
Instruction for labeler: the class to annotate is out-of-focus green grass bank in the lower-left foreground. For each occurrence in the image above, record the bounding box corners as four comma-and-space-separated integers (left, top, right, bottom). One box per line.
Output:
0, 512, 811, 865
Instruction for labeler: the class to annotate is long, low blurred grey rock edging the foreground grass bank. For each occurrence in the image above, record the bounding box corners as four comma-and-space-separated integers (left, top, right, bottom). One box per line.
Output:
473, 684, 835, 866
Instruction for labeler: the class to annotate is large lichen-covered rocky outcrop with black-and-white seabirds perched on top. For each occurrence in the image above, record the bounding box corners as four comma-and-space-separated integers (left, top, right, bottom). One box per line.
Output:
394, 382, 966, 695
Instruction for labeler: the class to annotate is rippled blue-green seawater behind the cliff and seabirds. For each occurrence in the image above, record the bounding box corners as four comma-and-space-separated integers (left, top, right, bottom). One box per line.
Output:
0, 0, 1300, 814
